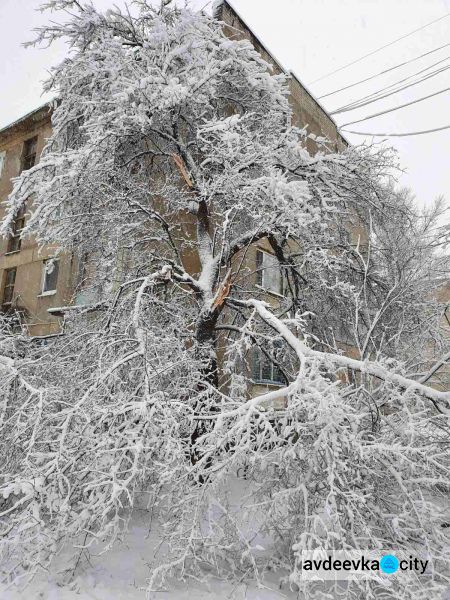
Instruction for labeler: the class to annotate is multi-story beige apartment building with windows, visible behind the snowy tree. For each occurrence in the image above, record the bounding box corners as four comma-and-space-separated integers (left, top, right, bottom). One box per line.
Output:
0, 1, 346, 342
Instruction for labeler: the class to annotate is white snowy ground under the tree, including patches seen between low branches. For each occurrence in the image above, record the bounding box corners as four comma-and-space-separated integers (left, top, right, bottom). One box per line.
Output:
0, 488, 450, 600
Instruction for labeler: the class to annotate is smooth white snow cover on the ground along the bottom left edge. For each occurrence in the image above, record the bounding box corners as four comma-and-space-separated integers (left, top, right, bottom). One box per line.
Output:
0, 511, 298, 600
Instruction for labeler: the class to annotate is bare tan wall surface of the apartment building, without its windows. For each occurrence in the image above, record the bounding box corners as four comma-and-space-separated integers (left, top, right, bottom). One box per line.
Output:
0, 2, 346, 336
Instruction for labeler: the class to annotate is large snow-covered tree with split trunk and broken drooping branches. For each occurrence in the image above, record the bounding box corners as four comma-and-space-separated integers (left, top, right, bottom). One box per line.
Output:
0, 0, 450, 600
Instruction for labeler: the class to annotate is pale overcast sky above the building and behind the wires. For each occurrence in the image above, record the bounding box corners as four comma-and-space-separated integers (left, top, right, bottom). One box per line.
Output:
0, 0, 450, 211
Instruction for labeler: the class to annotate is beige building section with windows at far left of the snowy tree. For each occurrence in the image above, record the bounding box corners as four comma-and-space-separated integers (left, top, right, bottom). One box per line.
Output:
0, 105, 74, 336
